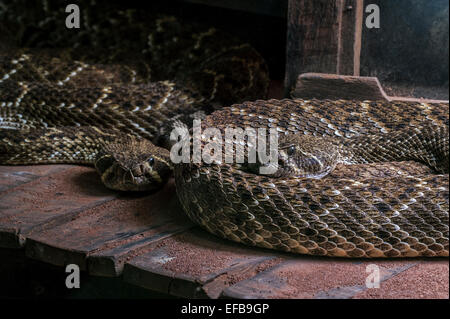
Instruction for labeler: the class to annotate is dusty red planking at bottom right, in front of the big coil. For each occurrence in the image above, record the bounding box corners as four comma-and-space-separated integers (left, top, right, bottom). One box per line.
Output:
222, 256, 448, 299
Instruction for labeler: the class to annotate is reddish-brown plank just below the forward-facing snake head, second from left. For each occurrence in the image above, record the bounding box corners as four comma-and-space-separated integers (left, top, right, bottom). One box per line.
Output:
26, 181, 193, 276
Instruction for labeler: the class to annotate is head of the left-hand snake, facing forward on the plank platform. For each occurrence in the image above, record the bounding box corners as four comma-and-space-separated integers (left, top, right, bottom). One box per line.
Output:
95, 137, 172, 191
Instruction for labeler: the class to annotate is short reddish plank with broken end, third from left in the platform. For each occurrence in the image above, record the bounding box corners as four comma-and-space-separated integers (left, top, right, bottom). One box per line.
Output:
123, 228, 283, 298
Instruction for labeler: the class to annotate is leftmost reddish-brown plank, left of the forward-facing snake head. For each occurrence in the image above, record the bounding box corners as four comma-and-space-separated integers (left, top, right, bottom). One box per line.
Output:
0, 166, 117, 248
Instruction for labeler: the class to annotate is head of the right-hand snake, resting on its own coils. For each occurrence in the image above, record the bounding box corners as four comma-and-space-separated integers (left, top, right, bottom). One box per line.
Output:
273, 134, 340, 178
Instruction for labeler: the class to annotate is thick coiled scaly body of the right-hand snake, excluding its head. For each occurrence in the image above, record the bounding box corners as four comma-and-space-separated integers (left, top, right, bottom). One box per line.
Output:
175, 100, 448, 257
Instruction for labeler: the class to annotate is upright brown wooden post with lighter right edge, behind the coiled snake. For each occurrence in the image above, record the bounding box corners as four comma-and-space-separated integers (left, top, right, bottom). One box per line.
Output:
285, 0, 364, 96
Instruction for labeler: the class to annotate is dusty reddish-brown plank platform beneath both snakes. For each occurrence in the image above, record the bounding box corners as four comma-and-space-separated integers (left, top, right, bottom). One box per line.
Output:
0, 165, 449, 298
